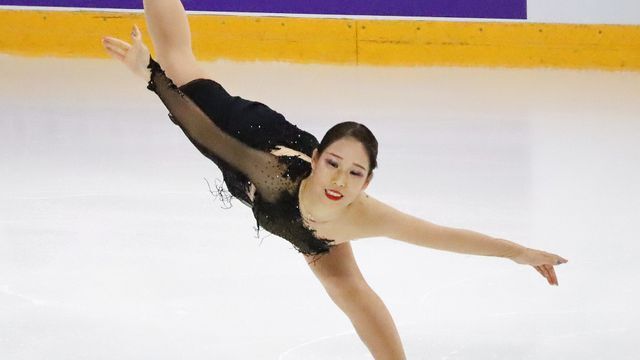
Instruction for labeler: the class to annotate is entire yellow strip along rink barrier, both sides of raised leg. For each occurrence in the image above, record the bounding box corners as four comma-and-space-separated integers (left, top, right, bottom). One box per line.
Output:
0, 10, 640, 71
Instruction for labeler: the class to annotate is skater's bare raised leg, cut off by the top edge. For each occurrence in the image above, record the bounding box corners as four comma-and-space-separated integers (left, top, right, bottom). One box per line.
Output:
143, 0, 209, 86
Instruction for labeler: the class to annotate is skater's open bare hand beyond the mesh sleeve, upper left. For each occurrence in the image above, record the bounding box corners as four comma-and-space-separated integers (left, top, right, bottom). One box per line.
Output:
102, 25, 150, 80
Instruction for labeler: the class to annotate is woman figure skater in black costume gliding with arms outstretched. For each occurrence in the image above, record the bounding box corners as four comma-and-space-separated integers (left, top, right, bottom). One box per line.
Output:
102, 0, 567, 359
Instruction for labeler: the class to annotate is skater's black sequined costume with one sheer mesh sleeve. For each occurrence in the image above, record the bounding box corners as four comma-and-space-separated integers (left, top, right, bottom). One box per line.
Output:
147, 58, 333, 255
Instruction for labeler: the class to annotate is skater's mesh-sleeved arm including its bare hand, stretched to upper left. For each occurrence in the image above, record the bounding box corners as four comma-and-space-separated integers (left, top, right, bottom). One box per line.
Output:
103, 27, 291, 201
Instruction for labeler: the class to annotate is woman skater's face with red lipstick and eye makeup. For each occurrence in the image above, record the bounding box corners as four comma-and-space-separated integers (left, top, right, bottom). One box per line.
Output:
311, 137, 372, 204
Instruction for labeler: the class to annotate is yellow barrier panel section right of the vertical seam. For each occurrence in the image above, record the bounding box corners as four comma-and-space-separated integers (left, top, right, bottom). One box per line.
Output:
358, 21, 640, 70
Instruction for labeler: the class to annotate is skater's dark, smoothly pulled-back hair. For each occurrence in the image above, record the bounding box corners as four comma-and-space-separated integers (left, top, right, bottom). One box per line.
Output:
318, 121, 378, 175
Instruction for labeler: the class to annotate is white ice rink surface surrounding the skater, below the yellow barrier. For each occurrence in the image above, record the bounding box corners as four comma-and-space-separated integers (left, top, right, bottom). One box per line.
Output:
0, 56, 640, 360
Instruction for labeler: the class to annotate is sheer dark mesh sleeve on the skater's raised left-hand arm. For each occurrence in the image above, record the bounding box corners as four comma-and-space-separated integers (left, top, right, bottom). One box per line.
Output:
147, 58, 292, 202
